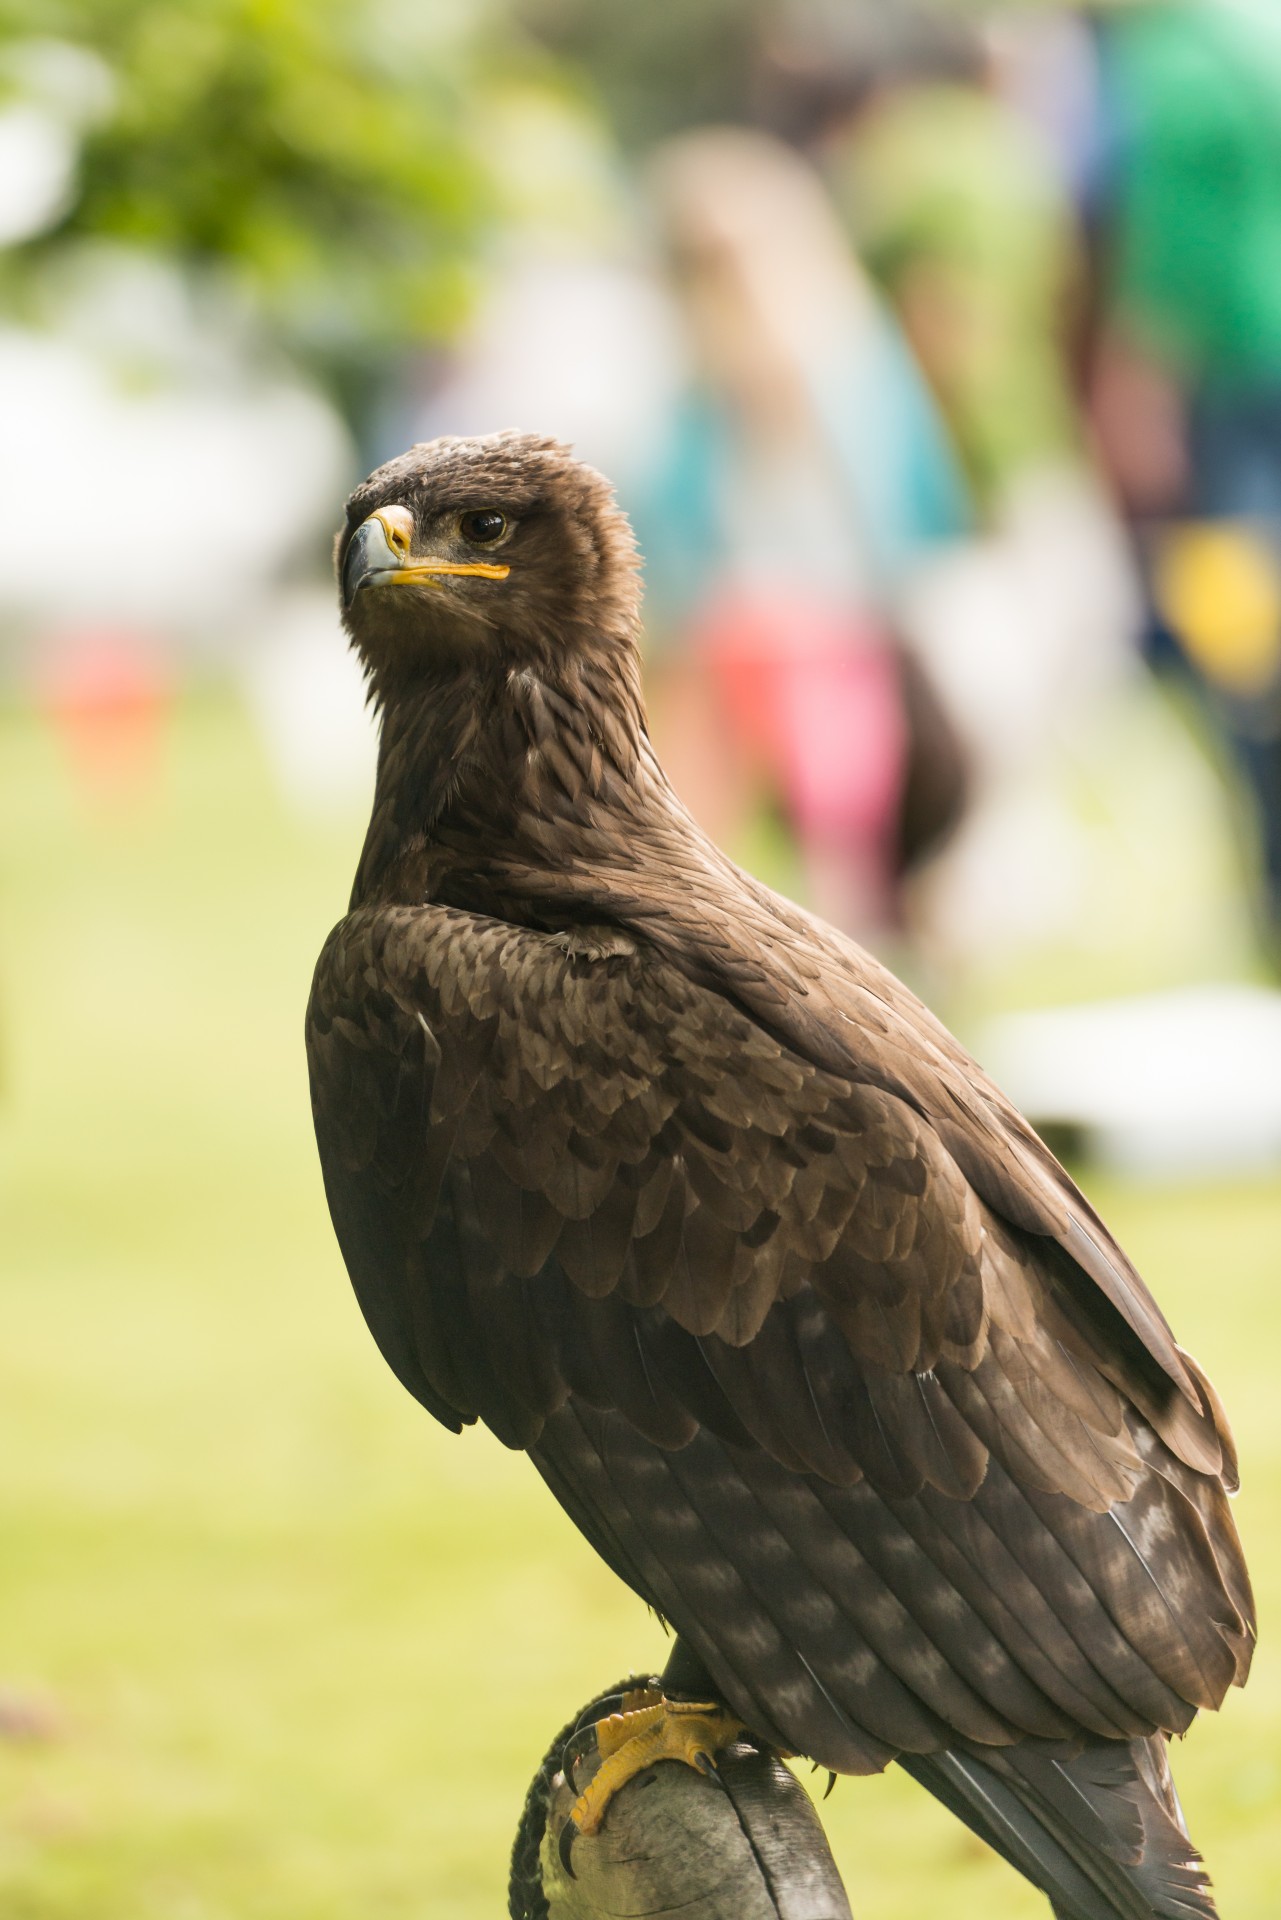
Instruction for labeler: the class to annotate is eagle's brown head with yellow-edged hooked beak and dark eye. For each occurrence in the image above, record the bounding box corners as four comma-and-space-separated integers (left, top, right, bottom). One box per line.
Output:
334, 432, 640, 695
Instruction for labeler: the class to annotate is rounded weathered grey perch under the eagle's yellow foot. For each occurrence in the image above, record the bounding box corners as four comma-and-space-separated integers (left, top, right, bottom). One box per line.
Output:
511, 1682, 851, 1920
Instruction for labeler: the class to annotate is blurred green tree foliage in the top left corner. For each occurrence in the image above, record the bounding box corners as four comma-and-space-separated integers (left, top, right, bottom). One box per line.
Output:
0, 0, 542, 413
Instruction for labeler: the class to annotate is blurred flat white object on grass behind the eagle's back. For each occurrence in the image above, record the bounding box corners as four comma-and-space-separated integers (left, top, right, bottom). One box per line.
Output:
978, 985, 1281, 1177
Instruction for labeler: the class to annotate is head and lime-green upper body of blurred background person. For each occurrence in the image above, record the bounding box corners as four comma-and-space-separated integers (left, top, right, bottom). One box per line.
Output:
774, 6, 1081, 522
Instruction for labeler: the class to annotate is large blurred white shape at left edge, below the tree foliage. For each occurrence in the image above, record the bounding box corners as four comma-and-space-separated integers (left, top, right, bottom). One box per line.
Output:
0, 328, 350, 634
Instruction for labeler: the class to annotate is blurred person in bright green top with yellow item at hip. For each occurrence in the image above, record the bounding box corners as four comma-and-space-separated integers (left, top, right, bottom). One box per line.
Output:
1091, 0, 1281, 958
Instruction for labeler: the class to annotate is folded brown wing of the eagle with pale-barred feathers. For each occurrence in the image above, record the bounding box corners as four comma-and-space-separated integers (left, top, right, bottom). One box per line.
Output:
309, 906, 1250, 1770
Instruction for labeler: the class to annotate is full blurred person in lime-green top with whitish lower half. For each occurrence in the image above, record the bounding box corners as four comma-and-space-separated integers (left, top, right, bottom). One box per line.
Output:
745, 0, 1248, 1010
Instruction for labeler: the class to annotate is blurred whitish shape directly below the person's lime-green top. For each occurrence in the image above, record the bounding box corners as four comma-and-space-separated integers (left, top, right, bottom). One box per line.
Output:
903, 470, 1250, 975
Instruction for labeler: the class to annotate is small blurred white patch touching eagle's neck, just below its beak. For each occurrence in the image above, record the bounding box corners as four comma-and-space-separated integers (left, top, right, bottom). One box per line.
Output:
242, 588, 378, 818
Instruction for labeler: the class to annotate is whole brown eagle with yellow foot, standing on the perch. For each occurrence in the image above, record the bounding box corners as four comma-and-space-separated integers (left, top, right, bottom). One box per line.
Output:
307, 434, 1254, 1920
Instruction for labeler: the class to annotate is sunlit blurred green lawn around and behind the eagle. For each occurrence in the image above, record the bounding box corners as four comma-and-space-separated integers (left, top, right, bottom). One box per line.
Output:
0, 693, 1281, 1920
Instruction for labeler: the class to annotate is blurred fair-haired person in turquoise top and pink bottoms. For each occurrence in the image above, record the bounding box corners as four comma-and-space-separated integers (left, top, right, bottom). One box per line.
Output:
624, 129, 968, 939
